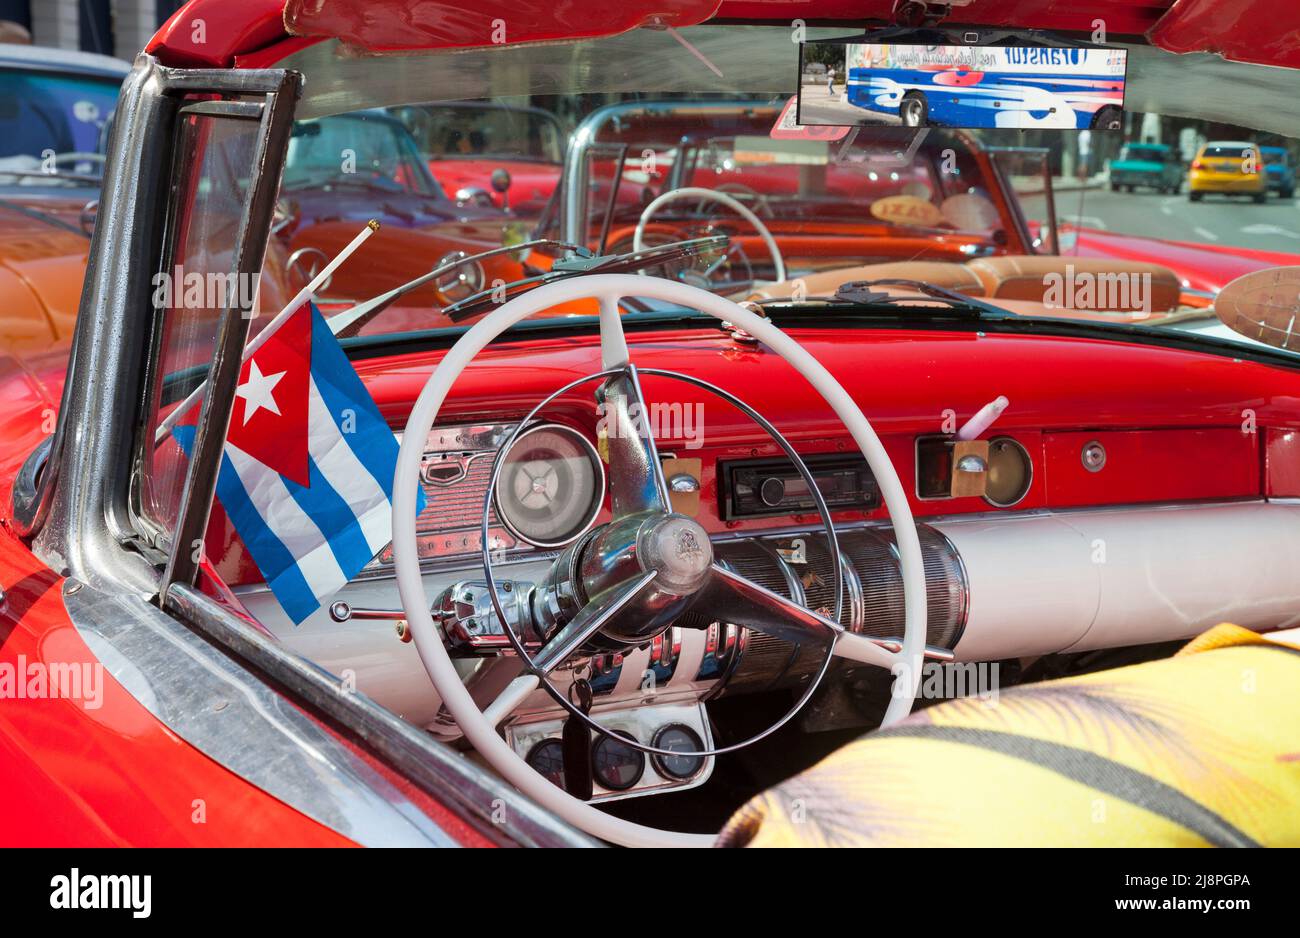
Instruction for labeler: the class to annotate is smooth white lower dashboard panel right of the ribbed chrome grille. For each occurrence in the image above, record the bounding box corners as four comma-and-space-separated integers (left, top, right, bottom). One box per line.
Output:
935, 501, 1300, 661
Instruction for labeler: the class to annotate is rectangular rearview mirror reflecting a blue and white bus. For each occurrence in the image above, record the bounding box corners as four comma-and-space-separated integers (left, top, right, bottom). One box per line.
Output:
798, 30, 1128, 130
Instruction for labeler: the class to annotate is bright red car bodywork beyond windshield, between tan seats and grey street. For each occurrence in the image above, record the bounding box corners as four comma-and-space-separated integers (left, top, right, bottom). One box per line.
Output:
1061, 225, 1300, 294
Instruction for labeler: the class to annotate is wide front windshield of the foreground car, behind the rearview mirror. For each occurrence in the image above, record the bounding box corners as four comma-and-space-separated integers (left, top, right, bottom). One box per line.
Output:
244, 26, 1300, 358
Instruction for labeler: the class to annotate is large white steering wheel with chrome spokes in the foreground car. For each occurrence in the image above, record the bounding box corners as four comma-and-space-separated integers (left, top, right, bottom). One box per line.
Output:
393, 274, 926, 847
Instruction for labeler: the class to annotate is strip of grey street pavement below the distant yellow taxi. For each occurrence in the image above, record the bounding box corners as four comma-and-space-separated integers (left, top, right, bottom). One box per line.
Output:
1021, 186, 1300, 253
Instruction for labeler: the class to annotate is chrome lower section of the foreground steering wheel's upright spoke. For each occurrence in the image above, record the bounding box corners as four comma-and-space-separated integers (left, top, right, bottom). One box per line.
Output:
603, 364, 672, 520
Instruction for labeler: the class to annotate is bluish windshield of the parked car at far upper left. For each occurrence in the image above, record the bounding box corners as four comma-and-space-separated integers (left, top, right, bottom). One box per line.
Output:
0, 66, 121, 187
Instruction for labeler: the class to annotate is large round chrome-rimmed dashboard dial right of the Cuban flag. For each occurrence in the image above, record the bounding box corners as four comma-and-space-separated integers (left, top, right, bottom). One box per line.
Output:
497, 424, 605, 547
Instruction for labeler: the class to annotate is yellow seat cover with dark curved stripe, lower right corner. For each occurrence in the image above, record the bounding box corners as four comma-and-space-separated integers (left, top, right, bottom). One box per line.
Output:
719, 625, 1300, 847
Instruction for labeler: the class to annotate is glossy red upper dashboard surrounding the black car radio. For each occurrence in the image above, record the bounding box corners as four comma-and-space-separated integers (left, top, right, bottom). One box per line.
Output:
188, 319, 1300, 586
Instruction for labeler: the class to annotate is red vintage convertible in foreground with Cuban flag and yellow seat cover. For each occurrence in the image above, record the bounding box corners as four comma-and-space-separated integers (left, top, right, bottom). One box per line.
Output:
0, 0, 1300, 847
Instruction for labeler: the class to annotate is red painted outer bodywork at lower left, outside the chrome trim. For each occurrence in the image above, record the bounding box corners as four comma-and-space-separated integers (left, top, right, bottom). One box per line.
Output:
0, 356, 361, 846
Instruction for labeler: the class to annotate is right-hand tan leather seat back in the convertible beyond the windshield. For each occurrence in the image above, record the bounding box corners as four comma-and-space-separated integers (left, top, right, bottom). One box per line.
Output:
966, 255, 1182, 313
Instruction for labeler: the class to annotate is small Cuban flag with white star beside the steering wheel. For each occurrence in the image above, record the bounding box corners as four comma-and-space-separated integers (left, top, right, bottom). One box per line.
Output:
173, 303, 424, 625
